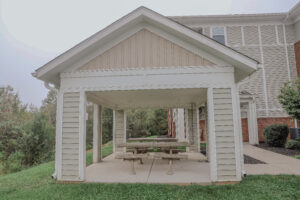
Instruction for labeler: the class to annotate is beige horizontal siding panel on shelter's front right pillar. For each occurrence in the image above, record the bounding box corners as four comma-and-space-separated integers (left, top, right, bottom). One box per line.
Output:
213, 88, 236, 181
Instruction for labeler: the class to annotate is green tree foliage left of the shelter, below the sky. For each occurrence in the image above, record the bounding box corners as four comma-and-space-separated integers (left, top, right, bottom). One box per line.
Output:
0, 86, 55, 172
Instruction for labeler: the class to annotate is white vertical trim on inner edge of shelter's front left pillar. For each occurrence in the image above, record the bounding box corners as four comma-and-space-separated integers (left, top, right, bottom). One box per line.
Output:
78, 91, 86, 181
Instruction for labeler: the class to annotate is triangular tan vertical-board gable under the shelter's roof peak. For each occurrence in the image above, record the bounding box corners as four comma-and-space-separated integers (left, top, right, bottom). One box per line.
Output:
78, 29, 215, 71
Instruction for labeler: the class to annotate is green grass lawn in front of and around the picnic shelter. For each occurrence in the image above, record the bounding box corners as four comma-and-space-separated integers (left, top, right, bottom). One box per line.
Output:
0, 141, 300, 200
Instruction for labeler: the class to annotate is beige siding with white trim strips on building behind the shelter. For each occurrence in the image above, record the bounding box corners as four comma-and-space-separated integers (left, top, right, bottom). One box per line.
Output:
170, 19, 297, 118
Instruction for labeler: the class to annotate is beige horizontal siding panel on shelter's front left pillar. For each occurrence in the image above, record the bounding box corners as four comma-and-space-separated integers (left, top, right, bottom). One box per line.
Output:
62, 92, 79, 180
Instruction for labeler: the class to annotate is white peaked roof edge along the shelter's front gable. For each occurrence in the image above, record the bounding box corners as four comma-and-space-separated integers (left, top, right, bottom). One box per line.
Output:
32, 7, 259, 83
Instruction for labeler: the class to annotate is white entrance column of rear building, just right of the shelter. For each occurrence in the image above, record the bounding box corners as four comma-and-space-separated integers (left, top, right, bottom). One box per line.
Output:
247, 101, 258, 145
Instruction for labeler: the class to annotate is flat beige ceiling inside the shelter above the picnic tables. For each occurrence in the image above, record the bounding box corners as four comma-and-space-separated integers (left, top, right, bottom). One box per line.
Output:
87, 88, 207, 109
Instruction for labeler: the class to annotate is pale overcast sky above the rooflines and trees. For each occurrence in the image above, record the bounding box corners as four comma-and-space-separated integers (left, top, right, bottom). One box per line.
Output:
0, 0, 300, 107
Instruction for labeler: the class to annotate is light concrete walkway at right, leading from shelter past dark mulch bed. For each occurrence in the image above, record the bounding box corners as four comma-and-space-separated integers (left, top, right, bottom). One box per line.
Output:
244, 143, 300, 175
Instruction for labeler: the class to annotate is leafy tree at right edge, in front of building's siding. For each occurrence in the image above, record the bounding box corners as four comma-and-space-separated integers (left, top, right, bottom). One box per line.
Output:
278, 78, 300, 120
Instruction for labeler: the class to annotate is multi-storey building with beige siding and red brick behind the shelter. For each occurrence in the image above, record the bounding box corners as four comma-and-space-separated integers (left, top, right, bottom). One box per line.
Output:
169, 3, 300, 144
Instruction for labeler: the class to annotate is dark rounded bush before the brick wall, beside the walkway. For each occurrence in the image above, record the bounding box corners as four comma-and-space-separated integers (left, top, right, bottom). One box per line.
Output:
264, 124, 289, 147
